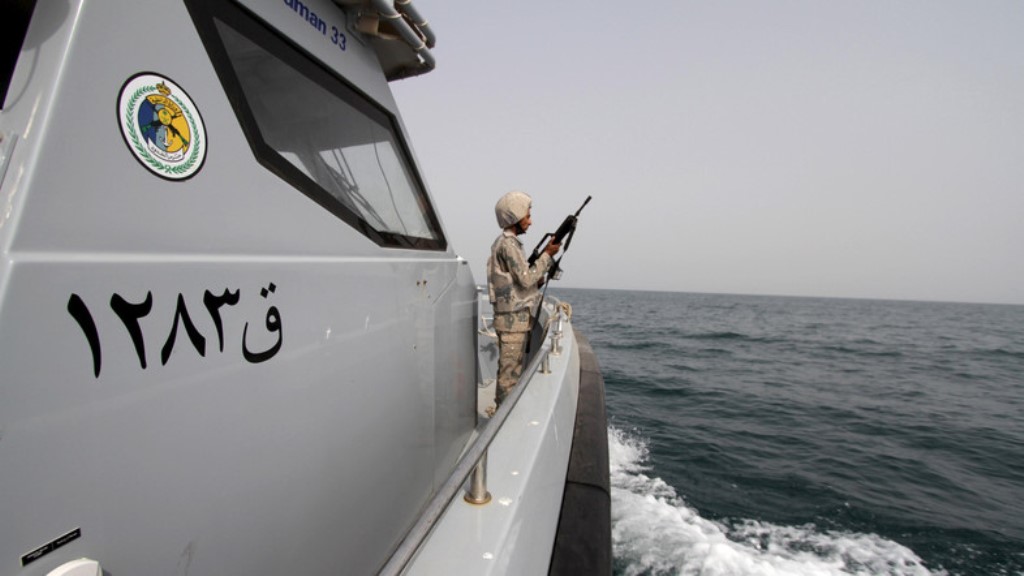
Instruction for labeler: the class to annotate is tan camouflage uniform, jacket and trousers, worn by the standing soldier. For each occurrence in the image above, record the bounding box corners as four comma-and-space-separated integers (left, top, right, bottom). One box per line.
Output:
487, 230, 552, 406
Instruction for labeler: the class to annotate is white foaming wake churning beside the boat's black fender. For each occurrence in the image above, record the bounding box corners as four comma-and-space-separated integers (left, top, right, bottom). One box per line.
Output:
608, 426, 945, 576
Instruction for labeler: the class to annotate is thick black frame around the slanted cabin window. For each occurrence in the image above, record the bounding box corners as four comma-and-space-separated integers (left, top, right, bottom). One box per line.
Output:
185, 0, 447, 251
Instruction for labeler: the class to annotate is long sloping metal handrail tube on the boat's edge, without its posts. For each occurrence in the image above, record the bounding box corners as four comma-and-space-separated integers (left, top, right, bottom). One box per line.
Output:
378, 308, 562, 576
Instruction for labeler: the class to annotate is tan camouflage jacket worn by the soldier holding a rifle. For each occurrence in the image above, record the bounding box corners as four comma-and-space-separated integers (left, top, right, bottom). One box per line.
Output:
487, 232, 552, 325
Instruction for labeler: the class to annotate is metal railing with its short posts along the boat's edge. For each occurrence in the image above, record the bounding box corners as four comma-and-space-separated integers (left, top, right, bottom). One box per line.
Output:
378, 306, 562, 576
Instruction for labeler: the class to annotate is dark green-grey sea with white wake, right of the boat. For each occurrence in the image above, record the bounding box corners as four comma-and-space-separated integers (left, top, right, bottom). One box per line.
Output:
552, 289, 1024, 576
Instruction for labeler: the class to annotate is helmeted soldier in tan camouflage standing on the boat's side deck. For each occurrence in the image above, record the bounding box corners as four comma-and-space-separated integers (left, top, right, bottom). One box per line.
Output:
487, 191, 561, 406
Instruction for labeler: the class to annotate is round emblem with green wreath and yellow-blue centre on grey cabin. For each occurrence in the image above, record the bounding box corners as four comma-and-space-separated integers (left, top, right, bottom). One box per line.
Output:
118, 72, 206, 180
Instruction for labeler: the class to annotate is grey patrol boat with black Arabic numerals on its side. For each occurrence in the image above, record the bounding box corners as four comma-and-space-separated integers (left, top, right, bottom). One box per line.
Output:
0, 0, 610, 576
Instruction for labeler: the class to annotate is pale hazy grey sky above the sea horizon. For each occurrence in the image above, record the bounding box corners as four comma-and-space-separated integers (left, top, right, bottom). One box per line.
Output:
392, 0, 1024, 304
